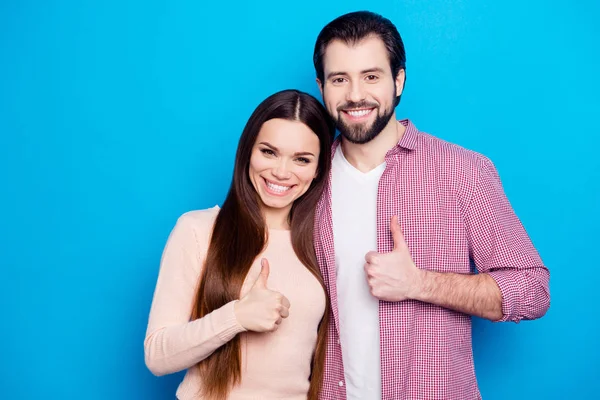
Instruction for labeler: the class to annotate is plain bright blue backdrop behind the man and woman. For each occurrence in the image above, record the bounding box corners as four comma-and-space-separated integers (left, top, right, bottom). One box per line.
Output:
0, 0, 600, 399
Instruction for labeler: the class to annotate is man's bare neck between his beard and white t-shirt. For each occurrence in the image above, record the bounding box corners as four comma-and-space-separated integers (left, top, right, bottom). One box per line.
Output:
341, 113, 406, 172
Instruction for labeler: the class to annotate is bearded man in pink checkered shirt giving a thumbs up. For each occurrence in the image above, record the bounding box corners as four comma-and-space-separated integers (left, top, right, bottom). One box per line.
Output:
314, 12, 550, 400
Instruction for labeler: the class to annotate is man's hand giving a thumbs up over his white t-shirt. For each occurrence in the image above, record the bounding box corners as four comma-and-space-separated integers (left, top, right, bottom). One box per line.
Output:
365, 216, 422, 301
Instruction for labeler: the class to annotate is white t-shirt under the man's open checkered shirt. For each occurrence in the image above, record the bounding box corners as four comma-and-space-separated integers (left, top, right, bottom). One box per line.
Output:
331, 145, 385, 400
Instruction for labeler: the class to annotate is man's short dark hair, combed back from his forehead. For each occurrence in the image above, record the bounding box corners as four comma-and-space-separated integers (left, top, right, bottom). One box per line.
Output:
313, 11, 406, 106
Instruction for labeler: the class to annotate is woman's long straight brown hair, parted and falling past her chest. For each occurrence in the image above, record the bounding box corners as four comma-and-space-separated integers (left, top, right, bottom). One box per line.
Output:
192, 90, 335, 400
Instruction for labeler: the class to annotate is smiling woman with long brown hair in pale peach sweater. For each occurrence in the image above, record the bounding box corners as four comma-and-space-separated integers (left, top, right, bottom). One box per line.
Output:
144, 90, 335, 400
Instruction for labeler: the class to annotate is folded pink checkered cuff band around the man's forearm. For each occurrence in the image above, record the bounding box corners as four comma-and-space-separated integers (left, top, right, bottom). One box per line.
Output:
487, 270, 527, 322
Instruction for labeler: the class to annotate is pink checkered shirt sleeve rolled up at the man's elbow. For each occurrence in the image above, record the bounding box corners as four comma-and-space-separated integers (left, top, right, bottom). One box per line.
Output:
466, 157, 550, 322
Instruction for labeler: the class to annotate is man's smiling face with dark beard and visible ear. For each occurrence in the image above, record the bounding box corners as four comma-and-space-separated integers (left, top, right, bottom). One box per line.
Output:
317, 36, 404, 144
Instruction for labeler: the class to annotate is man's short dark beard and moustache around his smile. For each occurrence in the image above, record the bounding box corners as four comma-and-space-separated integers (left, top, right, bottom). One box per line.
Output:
336, 100, 394, 144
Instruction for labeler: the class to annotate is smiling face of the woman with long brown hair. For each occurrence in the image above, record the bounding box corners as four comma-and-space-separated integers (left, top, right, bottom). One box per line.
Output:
248, 118, 319, 217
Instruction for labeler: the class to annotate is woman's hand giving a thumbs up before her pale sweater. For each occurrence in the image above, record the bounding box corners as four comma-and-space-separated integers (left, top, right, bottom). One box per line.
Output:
234, 258, 290, 332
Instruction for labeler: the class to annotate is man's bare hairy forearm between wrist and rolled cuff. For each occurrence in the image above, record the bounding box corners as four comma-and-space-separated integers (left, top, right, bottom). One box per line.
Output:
412, 270, 502, 321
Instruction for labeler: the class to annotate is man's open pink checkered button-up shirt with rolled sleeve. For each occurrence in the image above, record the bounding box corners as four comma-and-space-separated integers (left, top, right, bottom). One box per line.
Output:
315, 120, 550, 400
